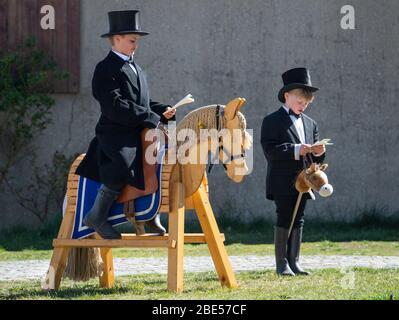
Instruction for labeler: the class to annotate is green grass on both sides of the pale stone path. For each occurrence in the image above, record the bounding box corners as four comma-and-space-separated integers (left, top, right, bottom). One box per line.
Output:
0, 216, 399, 300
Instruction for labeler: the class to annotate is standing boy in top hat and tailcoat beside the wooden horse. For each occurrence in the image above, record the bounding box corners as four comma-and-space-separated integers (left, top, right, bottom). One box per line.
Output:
261, 68, 326, 276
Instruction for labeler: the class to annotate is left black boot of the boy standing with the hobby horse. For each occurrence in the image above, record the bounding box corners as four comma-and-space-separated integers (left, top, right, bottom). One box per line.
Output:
274, 227, 295, 276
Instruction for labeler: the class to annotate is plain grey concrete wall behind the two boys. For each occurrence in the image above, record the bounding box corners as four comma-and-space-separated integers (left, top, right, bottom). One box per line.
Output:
0, 0, 399, 230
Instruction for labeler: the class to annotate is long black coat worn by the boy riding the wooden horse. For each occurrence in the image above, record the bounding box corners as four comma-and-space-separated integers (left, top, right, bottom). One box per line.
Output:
76, 51, 174, 190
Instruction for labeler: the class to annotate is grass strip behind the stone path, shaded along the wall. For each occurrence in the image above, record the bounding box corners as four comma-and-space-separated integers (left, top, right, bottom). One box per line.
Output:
0, 213, 399, 261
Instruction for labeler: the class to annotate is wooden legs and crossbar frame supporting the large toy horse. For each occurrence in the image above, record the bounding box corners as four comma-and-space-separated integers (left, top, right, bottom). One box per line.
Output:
42, 155, 237, 293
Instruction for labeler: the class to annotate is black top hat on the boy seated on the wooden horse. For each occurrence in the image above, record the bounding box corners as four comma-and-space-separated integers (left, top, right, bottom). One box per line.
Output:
101, 10, 149, 38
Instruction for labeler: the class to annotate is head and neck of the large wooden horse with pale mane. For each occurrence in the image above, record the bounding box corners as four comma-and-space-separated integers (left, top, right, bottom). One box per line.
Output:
177, 98, 253, 195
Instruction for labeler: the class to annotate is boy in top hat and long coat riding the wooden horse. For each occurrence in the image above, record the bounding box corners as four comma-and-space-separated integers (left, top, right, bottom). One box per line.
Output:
76, 10, 175, 239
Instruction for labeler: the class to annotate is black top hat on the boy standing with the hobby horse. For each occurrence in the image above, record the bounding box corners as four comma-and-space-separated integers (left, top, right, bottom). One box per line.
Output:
278, 68, 319, 103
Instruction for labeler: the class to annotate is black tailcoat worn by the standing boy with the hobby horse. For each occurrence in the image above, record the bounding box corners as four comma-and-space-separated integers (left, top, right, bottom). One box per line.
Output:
261, 107, 325, 200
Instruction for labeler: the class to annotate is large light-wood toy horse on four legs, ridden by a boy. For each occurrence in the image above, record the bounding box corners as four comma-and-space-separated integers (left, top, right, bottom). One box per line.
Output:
42, 98, 252, 293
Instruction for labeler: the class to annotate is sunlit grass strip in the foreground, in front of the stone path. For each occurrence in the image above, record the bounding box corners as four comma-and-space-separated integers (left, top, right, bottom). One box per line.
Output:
0, 268, 399, 300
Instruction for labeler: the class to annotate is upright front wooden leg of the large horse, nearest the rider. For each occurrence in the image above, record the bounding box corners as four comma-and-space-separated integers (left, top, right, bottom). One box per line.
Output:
168, 182, 185, 293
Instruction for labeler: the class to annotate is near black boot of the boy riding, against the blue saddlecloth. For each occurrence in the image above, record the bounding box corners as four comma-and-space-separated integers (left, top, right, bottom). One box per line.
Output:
83, 185, 122, 240
